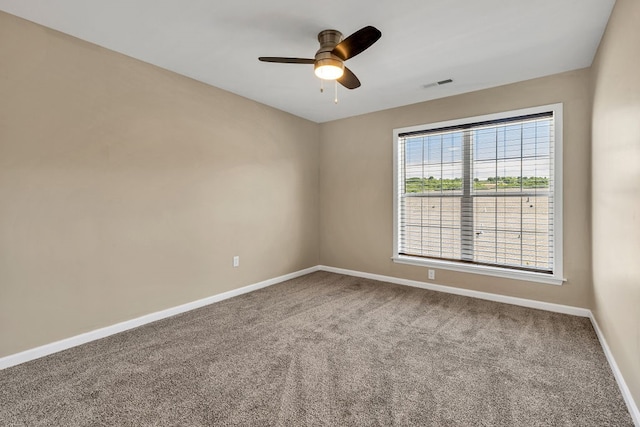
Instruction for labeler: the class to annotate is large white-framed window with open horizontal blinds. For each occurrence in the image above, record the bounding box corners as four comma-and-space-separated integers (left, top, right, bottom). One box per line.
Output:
393, 104, 563, 284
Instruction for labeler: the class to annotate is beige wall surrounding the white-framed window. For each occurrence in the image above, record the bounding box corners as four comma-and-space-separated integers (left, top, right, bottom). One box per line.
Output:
320, 69, 592, 307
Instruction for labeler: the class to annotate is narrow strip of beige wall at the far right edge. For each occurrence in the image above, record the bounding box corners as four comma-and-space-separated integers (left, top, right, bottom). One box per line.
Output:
592, 0, 640, 403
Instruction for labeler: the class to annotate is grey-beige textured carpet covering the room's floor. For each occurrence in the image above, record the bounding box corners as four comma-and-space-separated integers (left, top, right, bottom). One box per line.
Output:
0, 272, 633, 426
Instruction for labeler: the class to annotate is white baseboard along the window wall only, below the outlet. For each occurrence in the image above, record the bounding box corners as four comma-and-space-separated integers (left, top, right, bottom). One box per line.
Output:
318, 265, 591, 317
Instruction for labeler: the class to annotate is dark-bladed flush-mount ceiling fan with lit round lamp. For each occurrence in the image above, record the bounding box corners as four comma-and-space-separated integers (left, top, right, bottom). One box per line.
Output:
258, 25, 382, 89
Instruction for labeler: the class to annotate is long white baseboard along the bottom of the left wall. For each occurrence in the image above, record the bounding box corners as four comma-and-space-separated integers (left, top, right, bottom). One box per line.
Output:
0, 266, 318, 369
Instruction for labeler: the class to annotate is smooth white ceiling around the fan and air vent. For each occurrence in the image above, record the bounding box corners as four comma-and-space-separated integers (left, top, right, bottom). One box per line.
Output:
0, 0, 615, 122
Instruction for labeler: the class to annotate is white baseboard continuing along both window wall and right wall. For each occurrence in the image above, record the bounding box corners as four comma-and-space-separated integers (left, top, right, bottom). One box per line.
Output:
318, 265, 640, 427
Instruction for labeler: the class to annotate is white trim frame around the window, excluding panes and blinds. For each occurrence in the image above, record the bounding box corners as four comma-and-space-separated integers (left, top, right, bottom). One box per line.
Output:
391, 103, 566, 285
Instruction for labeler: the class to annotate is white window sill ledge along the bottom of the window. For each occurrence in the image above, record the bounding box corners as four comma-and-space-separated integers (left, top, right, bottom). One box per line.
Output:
391, 255, 566, 285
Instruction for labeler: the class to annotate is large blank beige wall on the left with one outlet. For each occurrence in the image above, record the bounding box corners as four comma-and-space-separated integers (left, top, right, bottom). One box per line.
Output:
0, 13, 319, 357
